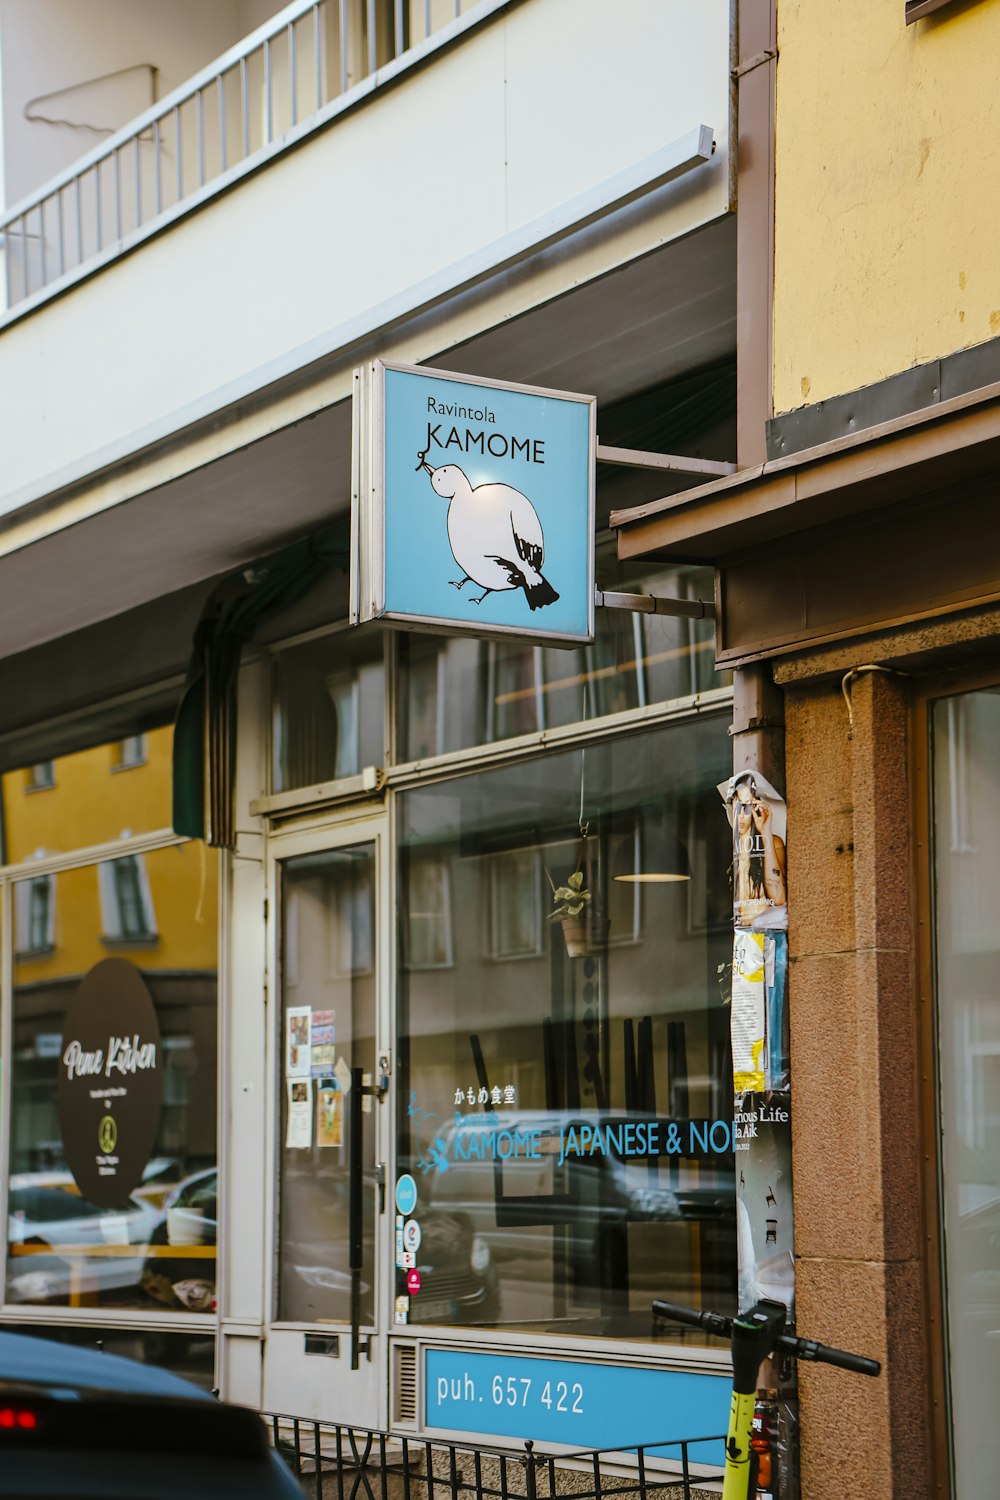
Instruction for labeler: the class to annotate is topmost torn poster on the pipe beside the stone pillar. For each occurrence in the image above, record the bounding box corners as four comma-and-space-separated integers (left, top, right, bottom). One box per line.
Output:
718, 771, 789, 932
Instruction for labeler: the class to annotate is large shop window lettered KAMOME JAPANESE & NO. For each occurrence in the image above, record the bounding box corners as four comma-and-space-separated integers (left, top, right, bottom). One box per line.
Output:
396, 719, 736, 1338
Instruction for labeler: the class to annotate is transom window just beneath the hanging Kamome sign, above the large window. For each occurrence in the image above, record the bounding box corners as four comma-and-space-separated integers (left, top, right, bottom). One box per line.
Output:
399, 563, 726, 761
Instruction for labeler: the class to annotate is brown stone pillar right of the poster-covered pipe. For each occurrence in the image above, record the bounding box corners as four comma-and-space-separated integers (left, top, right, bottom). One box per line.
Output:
786, 672, 937, 1500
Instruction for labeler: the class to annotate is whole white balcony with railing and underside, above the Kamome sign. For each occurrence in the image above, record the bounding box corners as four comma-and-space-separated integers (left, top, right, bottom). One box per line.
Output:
0, 0, 735, 663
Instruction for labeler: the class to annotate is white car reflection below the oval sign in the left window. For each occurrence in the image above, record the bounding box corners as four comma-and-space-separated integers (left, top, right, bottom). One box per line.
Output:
7, 1173, 160, 1302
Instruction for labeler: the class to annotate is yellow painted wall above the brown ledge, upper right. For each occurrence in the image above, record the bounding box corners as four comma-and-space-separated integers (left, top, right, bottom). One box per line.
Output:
774, 0, 1000, 413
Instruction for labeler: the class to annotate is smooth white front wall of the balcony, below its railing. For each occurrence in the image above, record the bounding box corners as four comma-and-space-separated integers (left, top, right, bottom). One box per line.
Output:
0, 0, 729, 513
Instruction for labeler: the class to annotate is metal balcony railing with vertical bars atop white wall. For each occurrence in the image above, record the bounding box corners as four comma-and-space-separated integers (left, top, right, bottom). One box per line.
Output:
0, 0, 497, 309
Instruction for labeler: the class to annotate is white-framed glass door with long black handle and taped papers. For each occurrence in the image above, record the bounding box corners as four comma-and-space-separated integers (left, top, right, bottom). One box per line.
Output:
264, 821, 390, 1425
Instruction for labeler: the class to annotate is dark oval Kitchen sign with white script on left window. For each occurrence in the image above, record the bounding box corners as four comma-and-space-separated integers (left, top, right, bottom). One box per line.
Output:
57, 959, 163, 1209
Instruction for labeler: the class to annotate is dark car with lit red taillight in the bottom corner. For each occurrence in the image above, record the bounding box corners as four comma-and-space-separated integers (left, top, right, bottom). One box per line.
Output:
0, 1332, 303, 1500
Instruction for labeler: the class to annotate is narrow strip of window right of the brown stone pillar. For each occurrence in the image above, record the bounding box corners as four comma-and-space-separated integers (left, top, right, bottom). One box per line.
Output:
933, 689, 1000, 1496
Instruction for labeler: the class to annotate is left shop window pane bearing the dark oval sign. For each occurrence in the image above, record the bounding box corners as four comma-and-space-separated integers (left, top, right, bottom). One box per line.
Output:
6, 846, 217, 1313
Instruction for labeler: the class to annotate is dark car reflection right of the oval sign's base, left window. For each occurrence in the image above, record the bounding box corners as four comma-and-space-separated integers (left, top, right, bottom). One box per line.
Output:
142, 1167, 219, 1313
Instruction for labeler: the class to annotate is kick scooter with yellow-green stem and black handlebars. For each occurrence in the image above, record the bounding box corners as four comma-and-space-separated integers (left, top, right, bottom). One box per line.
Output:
652, 1301, 882, 1500
